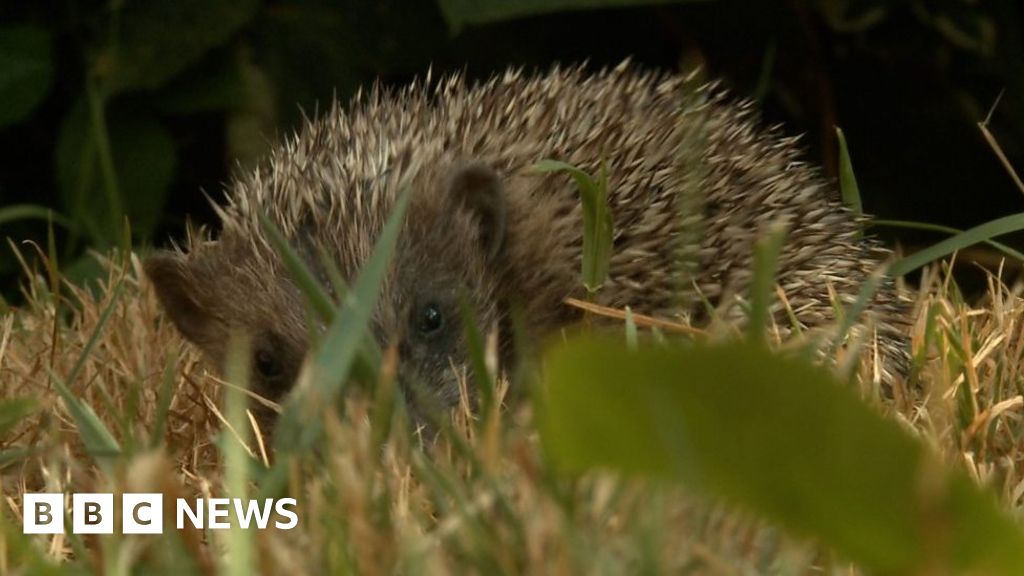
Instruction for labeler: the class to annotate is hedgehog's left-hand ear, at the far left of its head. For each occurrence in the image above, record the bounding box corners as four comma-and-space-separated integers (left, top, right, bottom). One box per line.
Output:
142, 252, 218, 345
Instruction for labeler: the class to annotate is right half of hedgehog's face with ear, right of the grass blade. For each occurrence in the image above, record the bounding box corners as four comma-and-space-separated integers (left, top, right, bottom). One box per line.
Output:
376, 164, 505, 410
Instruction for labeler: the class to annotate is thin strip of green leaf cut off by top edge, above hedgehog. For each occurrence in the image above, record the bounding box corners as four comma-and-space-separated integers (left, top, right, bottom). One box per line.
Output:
437, 0, 708, 32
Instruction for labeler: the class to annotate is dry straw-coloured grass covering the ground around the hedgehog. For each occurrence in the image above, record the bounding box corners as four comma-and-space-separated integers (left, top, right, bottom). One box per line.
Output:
0, 243, 1024, 574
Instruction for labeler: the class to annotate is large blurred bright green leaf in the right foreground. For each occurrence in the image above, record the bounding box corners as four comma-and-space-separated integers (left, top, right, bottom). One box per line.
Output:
539, 340, 1024, 574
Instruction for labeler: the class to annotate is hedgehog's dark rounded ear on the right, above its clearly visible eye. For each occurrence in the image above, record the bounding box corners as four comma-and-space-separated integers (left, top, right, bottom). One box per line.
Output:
449, 164, 505, 257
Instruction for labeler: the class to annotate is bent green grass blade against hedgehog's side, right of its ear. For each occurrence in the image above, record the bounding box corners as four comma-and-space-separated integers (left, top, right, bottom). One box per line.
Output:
534, 160, 613, 294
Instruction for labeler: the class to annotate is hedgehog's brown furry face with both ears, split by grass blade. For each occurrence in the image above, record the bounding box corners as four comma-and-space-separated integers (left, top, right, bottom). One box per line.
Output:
145, 158, 505, 424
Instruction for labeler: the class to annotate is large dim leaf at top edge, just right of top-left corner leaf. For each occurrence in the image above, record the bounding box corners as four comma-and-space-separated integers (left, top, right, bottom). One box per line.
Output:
95, 0, 259, 94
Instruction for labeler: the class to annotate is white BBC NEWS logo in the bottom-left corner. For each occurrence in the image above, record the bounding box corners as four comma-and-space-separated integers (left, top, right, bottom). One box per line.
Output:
22, 492, 299, 534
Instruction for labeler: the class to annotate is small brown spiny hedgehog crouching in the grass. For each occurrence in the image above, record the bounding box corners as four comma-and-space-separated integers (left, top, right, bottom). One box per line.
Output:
145, 63, 907, 412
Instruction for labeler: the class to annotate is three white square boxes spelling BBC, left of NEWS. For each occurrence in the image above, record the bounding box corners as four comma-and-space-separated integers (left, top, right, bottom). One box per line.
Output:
22, 493, 164, 534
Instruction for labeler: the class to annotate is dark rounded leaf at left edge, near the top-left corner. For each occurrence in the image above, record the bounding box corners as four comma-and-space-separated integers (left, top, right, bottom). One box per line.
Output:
0, 26, 53, 127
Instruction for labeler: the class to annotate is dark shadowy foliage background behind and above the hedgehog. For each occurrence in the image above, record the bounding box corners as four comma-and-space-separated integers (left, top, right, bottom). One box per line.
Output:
0, 0, 1024, 301
